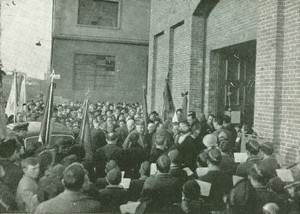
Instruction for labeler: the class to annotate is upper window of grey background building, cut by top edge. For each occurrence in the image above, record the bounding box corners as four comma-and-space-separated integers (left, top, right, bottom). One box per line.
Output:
77, 0, 119, 28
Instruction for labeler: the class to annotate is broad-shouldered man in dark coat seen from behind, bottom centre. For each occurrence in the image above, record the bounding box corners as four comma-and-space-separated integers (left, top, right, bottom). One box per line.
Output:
141, 155, 182, 213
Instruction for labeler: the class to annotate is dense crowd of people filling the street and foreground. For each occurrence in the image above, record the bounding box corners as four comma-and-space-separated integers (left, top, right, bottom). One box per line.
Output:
0, 100, 299, 214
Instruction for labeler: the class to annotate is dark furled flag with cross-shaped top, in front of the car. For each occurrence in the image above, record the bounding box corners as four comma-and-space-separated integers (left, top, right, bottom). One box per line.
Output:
38, 79, 54, 148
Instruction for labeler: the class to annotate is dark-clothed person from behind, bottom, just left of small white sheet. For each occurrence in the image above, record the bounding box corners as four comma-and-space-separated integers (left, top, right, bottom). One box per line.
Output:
98, 168, 128, 213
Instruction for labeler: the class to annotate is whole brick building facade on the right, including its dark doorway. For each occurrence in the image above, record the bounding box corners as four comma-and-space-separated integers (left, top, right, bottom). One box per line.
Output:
148, 0, 300, 166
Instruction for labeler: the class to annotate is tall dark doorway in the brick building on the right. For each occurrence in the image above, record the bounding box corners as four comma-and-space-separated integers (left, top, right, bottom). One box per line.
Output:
217, 41, 256, 125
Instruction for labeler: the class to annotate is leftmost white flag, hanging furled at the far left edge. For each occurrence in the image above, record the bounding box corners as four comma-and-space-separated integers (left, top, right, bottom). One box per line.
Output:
5, 72, 18, 120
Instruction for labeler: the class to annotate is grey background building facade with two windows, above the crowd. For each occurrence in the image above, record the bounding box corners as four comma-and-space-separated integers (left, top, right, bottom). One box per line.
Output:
52, 0, 150, 102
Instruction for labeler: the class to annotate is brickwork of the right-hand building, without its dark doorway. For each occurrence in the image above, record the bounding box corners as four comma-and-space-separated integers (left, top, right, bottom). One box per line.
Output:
148, 0, 300, 170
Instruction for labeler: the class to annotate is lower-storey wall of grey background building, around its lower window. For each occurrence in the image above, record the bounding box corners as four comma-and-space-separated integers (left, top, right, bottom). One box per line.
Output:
53, 39, 148, 102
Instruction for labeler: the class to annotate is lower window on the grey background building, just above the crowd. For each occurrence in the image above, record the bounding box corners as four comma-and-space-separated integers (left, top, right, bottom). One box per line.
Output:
73, 54, 115, 90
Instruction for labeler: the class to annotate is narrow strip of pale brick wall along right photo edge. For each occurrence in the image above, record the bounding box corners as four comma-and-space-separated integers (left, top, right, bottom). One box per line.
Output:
279, 0, 300, 166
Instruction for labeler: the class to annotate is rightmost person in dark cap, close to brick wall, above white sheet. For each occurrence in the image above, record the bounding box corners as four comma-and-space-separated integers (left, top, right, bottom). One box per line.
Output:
259, 142, 280, 179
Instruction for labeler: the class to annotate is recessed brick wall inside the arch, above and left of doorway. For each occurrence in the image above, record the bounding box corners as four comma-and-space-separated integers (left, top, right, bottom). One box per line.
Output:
204, 0, 257, 114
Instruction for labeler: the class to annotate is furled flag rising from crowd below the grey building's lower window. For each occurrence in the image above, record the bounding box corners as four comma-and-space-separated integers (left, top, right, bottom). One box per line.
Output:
79, 98, 93, 161
